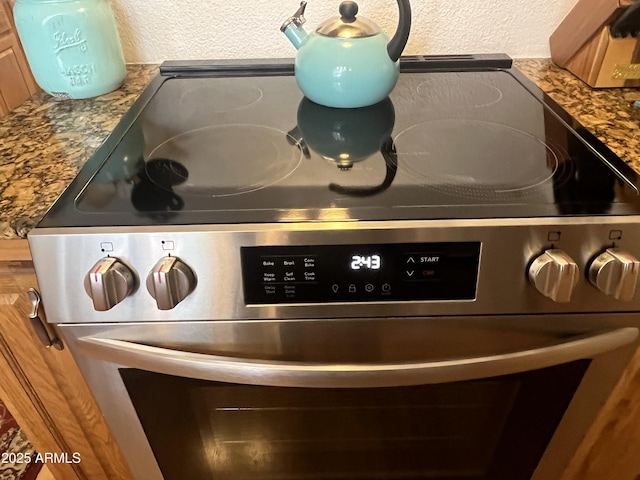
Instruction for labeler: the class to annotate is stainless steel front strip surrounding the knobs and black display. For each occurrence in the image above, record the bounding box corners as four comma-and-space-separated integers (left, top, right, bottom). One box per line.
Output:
29, 216, 640, 324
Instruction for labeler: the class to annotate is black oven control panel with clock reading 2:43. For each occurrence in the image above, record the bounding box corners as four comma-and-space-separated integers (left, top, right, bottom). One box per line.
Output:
241, 242, 480, 305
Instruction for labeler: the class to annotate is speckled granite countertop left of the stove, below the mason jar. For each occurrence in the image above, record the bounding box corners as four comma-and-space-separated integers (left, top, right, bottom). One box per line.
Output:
0, 65, 158, 239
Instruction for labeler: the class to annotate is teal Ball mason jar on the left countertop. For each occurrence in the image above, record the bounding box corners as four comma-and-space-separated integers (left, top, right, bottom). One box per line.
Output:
13, 0, 126, 99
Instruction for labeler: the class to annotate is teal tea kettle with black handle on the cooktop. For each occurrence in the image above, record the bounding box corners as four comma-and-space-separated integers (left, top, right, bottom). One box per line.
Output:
281, 0, 411, 108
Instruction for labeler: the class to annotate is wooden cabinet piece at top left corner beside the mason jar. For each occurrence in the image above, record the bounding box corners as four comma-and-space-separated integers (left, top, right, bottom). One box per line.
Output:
0, 0, 38, 117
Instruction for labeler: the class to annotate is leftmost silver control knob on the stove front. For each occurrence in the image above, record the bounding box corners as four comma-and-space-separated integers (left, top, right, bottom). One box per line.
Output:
84, 257, 136, 312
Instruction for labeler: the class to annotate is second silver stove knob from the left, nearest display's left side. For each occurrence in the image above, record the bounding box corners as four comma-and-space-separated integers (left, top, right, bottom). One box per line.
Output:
147, 257, 196, 310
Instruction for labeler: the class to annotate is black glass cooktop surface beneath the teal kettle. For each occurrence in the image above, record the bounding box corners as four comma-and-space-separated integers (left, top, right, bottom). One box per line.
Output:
40, 56, 640, 227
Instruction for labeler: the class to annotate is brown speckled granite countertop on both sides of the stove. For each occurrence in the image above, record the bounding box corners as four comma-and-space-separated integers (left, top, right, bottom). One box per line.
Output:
0, 59, 640, 239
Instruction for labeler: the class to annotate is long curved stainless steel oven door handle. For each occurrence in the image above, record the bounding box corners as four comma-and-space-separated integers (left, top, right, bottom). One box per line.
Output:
78, 327, 638, 388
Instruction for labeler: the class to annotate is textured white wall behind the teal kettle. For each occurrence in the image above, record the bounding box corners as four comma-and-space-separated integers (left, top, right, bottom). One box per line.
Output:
111, 0, 577, 63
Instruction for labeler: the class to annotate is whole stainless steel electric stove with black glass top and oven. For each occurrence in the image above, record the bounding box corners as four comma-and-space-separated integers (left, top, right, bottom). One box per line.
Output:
29, 55, 640, 480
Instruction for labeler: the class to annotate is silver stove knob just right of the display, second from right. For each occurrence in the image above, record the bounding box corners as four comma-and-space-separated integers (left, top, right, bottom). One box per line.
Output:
529, 249, 580, 303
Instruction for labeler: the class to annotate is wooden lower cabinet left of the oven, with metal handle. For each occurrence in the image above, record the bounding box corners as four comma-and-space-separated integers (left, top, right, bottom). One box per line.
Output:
0, 240, 131, 480
